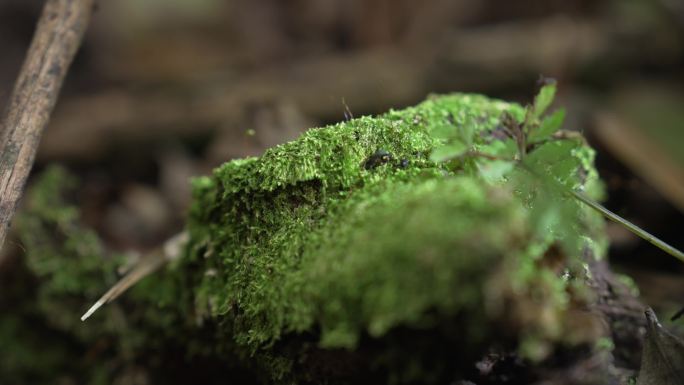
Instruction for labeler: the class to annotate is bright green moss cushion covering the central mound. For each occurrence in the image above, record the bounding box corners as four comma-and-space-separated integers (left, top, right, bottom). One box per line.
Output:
180, 95, 602, 378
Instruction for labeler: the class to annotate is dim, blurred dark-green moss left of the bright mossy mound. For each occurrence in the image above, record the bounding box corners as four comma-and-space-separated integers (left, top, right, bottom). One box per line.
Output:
0, 166, 256, 384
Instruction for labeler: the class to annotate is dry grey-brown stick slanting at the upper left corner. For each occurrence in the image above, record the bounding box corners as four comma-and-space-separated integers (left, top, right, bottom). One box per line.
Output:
0, 0, 93, 247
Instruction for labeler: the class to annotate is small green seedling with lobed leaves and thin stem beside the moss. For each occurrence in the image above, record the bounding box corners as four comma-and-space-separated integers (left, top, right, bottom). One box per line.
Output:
431, 79, 684, 262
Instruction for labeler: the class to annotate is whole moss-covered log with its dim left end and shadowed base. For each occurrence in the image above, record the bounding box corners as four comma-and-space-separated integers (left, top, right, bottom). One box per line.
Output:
0, 94, 648, 384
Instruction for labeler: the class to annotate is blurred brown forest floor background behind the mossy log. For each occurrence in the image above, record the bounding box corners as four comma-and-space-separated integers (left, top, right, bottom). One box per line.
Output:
0, 0, 684, 323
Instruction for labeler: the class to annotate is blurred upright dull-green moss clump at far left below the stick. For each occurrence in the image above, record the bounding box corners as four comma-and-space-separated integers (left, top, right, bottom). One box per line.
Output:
17, 167, 121, 340
